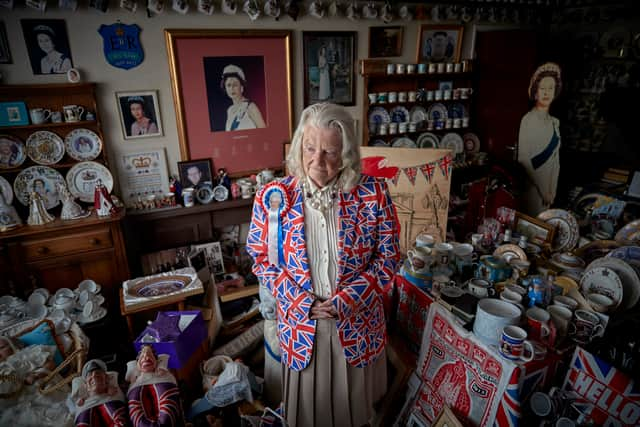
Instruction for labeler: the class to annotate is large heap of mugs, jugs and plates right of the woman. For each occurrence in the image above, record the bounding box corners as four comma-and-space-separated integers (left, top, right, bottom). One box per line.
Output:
401, 209, 640, 362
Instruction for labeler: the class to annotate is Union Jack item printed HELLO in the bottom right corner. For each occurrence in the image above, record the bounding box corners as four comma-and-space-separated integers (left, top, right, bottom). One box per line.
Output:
562, 347, 640, 426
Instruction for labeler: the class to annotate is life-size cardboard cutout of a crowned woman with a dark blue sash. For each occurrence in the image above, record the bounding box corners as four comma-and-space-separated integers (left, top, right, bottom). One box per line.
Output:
518, 62, 562, 215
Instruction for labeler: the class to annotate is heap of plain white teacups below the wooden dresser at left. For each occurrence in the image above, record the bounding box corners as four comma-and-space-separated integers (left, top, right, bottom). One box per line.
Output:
0, 279, 107, 351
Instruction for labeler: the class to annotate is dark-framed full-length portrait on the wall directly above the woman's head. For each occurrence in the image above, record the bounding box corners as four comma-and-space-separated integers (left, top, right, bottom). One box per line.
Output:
302, 31, 357, 107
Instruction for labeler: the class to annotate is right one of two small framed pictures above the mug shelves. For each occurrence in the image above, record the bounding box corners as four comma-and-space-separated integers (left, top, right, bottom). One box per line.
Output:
416, 24, 464, 62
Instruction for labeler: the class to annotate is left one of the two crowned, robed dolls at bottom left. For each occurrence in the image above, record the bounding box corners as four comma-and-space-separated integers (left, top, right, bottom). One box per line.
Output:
71, 359, 131, 427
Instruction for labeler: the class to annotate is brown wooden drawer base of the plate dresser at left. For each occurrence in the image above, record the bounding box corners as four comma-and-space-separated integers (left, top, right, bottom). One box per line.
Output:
0, 212, 129, 308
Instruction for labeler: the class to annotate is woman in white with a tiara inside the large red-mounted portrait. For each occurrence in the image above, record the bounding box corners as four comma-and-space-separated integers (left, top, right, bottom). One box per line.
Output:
221, 64, 267, 131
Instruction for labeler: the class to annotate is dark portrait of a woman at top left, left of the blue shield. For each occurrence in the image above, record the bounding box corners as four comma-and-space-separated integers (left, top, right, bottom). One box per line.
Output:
20, 19, 73, 74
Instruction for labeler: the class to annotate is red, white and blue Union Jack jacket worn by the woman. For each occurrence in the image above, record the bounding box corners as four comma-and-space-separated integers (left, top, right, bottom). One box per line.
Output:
247, 175, 400, 371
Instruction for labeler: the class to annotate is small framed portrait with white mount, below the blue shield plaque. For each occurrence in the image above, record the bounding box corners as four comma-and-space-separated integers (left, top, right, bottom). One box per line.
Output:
116, 90, 162, 139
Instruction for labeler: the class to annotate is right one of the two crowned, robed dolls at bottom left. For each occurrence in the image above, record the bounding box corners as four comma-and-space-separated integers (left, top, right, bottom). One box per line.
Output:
125, 345, 184, 427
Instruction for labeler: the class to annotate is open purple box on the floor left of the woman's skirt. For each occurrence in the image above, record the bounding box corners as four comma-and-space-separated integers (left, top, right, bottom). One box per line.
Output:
133, 310, 207, 369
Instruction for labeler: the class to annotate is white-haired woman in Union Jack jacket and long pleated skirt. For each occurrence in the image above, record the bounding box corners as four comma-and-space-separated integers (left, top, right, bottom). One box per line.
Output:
247, 103, 399, 427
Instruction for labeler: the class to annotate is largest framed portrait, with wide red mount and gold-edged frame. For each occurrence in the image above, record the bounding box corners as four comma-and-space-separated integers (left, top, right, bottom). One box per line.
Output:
165, 29, 293, 175
